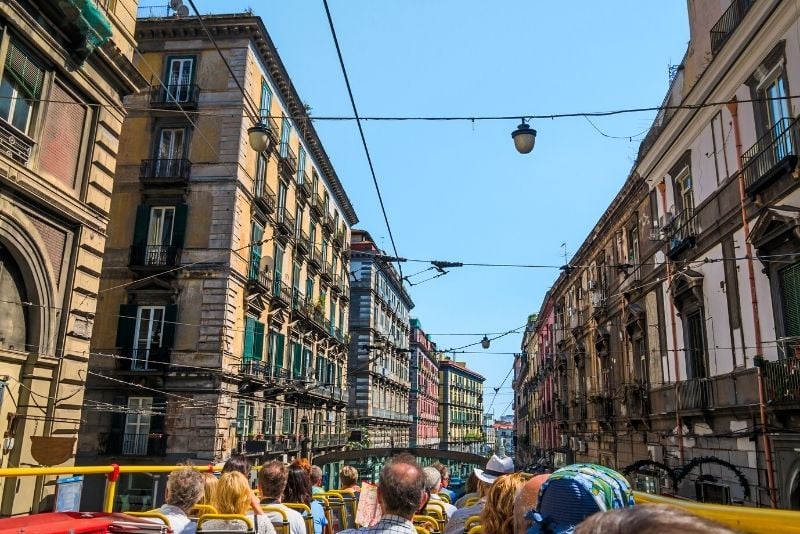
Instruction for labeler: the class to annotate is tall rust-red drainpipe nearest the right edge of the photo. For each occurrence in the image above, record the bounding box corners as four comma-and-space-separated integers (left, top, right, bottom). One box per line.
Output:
728, 97, 778, 508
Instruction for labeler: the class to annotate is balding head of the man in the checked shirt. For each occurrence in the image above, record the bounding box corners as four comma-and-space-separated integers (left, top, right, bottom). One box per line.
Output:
378, 459, 425, 519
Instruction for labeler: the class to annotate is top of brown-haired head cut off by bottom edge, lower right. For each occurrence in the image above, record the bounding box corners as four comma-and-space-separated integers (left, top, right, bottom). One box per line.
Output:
575, 504, 735, 534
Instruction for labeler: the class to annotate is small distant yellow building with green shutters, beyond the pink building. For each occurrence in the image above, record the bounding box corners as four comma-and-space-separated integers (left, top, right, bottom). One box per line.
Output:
439, 357, 486, 454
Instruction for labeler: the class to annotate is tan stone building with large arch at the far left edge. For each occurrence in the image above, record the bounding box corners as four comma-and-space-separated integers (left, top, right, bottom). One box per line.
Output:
0, 0, 146, 516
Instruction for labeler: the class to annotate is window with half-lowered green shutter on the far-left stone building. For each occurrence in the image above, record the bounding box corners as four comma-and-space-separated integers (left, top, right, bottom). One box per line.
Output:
0, 42, 44, 134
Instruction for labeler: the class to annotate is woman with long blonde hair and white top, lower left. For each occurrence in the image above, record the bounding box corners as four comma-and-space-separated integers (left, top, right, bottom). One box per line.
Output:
203, 471, 275, 534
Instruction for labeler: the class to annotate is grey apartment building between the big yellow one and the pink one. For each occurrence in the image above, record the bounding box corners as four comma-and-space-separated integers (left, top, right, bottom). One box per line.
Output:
348, 230, 414, 447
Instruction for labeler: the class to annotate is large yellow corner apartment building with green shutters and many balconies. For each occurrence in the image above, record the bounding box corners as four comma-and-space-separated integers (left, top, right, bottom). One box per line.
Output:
78, 10, 357, 507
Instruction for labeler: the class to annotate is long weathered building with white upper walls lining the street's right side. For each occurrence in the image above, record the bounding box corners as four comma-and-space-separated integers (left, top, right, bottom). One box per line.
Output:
522, 0, 800, 508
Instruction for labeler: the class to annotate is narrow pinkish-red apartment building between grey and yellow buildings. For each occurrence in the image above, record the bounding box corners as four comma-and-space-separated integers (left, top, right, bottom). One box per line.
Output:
408, 319, 439, 448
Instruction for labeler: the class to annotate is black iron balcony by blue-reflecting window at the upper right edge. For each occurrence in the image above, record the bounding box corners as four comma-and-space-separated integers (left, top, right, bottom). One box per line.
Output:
742, 118, 800, 198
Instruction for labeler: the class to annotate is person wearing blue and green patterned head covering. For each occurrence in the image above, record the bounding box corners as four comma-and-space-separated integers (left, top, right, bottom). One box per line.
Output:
526, 464, 634, 534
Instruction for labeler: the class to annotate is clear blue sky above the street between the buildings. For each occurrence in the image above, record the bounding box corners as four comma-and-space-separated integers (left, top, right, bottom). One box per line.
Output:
194, 0, 689, 417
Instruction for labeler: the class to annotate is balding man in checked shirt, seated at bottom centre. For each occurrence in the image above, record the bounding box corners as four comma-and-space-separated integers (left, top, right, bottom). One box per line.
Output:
339, 457, 425, 534
